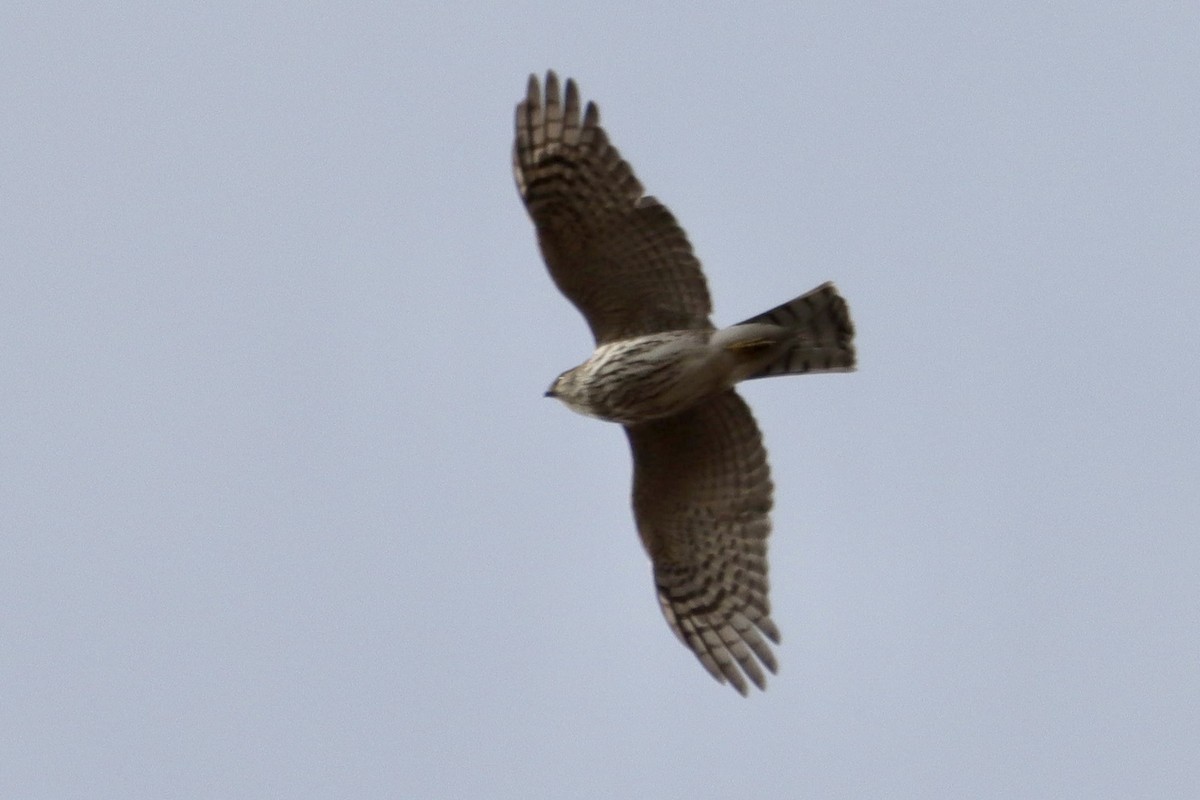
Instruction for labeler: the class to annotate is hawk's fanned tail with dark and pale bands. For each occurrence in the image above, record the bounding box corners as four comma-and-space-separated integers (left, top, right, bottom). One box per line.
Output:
739, 283, 856, 380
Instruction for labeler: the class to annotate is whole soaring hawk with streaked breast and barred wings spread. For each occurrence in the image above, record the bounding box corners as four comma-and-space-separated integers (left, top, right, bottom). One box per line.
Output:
512, 72, 854, 696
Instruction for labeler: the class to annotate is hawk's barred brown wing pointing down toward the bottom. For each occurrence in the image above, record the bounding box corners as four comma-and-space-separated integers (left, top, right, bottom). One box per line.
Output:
625, 390, 779, 694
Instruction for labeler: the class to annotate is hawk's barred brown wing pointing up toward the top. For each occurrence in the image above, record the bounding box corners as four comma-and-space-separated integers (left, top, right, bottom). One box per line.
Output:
512, 72, 712, 344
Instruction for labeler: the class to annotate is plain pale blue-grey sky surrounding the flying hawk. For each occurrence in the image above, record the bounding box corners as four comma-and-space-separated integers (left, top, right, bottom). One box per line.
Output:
0, 0, 1200, 800
